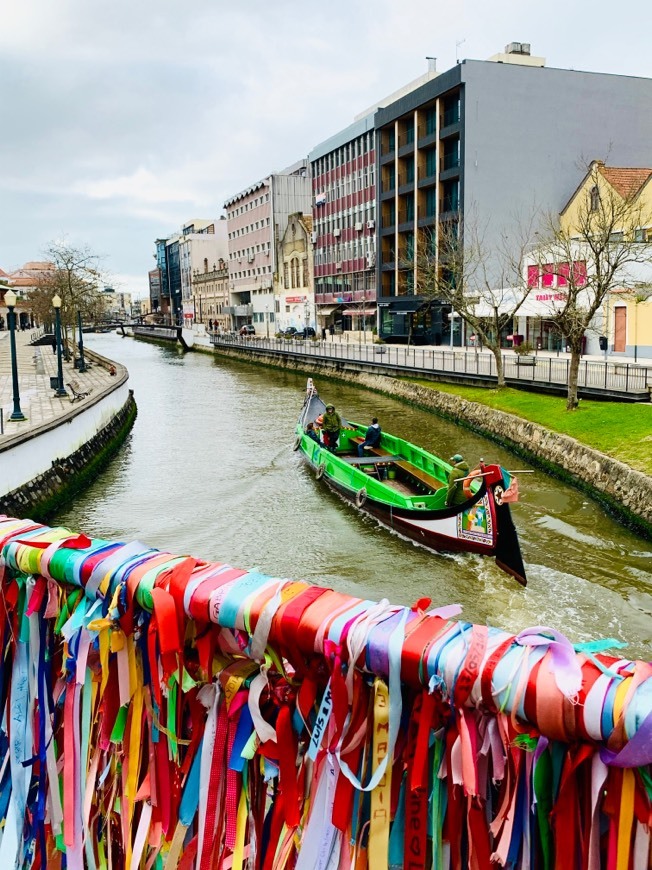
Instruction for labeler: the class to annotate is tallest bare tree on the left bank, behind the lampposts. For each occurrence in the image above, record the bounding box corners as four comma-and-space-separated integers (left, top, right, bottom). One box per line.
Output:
30, 242, 105, 352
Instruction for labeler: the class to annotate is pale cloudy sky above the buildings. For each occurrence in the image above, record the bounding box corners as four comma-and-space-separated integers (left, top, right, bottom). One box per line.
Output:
0, 0, 652, 295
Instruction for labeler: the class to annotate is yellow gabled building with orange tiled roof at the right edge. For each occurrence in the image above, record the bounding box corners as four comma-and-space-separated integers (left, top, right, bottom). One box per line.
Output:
560, 160, 652, 361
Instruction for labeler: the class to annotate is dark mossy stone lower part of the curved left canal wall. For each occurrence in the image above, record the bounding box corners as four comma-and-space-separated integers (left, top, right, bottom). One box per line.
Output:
0, 390, 136, 521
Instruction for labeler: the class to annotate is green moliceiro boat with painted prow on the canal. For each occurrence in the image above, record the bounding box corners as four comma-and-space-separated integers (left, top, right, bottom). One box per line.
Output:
294, 378, 527, 586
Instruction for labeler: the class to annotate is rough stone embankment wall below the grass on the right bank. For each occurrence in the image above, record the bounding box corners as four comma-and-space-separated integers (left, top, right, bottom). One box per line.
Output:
209, 348, 652, 537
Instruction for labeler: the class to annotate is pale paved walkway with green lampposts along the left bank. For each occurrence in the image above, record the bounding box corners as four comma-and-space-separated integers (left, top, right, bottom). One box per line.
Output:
0, 330, 115, 447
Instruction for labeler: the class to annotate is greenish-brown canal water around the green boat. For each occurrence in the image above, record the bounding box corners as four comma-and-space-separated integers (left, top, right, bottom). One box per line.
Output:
53, 335, 652, 659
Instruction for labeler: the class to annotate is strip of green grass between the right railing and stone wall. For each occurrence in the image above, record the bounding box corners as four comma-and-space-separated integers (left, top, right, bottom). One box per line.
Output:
402, 378, 652, 475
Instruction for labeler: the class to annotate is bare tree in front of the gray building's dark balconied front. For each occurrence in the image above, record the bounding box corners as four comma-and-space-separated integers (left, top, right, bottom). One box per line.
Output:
399, 212, 535, 387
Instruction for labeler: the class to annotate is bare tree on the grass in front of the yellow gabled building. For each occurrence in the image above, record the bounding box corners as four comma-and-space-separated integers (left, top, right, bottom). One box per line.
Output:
537, 161, 652, 411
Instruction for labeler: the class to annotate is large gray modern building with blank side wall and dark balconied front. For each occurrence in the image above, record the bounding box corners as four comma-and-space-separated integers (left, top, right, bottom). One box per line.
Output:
374, 43, 652, 344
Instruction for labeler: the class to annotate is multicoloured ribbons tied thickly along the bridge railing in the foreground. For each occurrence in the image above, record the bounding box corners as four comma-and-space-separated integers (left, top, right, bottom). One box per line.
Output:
0, 517, 652, 870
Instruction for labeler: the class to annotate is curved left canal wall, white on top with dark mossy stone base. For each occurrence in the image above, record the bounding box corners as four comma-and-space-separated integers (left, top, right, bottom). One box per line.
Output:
0, 352, 137, 520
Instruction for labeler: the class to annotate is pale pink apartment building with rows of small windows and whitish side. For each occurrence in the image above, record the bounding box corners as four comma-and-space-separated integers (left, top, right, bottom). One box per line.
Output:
224, 160, 310, 328
